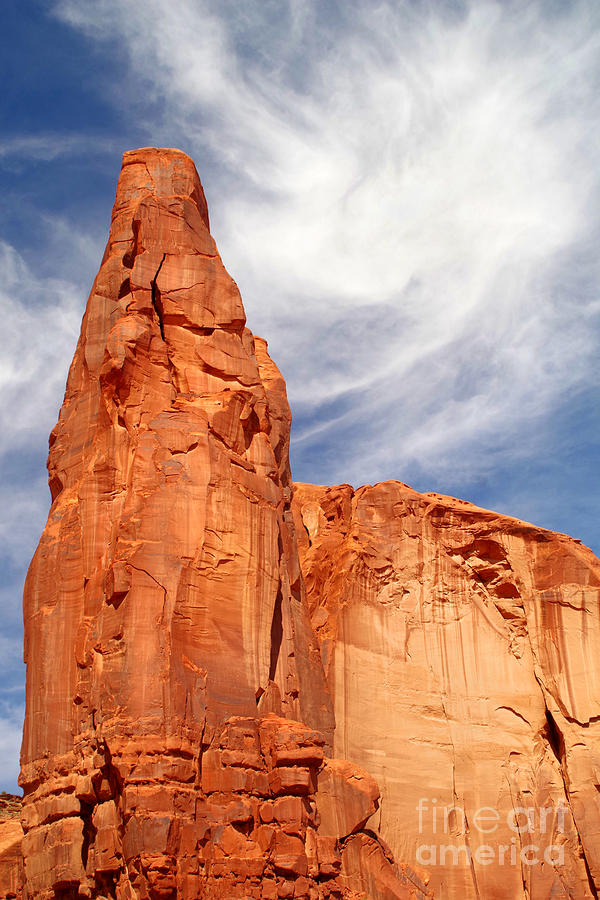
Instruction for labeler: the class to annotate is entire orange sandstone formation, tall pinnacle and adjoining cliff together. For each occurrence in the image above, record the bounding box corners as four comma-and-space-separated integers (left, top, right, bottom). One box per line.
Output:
17, 148, 600, 900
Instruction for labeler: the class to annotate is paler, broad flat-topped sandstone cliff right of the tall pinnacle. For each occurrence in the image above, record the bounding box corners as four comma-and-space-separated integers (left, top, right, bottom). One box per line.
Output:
294, 482, 600, 900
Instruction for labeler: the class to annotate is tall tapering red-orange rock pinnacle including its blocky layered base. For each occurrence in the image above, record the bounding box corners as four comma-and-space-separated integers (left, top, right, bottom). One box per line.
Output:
21, 149, 425, 900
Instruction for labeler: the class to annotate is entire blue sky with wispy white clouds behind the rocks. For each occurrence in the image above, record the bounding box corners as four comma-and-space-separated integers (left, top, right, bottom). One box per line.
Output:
0, 0, 600, 789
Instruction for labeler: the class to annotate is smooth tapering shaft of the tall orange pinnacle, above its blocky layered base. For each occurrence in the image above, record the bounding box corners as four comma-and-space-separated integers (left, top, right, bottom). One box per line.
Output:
23, 150, 333, 763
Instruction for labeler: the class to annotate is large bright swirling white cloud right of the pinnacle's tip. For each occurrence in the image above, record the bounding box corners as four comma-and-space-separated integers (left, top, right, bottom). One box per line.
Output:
49, 0, 600, 492
